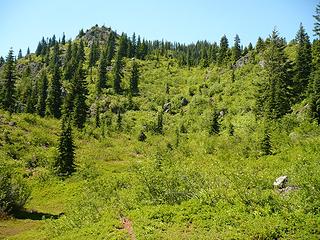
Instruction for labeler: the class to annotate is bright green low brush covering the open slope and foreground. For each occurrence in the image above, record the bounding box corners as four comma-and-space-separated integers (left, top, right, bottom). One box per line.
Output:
0, 6, 320, 239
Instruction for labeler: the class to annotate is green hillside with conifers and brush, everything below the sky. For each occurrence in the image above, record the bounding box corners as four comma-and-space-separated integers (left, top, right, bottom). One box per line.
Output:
0, 5, 320, 239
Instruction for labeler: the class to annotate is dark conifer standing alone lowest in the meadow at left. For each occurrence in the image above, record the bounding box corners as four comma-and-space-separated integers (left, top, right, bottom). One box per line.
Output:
54, 116, 76, 176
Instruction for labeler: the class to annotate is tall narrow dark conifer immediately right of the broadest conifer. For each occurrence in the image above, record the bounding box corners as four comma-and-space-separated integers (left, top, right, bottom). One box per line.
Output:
293, 24, 312, 101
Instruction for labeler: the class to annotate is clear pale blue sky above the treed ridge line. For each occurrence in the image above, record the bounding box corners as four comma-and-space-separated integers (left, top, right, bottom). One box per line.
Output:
0, 0, 319, 56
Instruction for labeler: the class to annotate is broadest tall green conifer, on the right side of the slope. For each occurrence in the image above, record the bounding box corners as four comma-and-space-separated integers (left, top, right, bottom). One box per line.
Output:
257, 30, 292, 119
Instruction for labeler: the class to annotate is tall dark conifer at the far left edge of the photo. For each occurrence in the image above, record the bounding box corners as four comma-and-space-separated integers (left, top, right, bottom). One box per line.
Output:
1, 49, 16, 113
